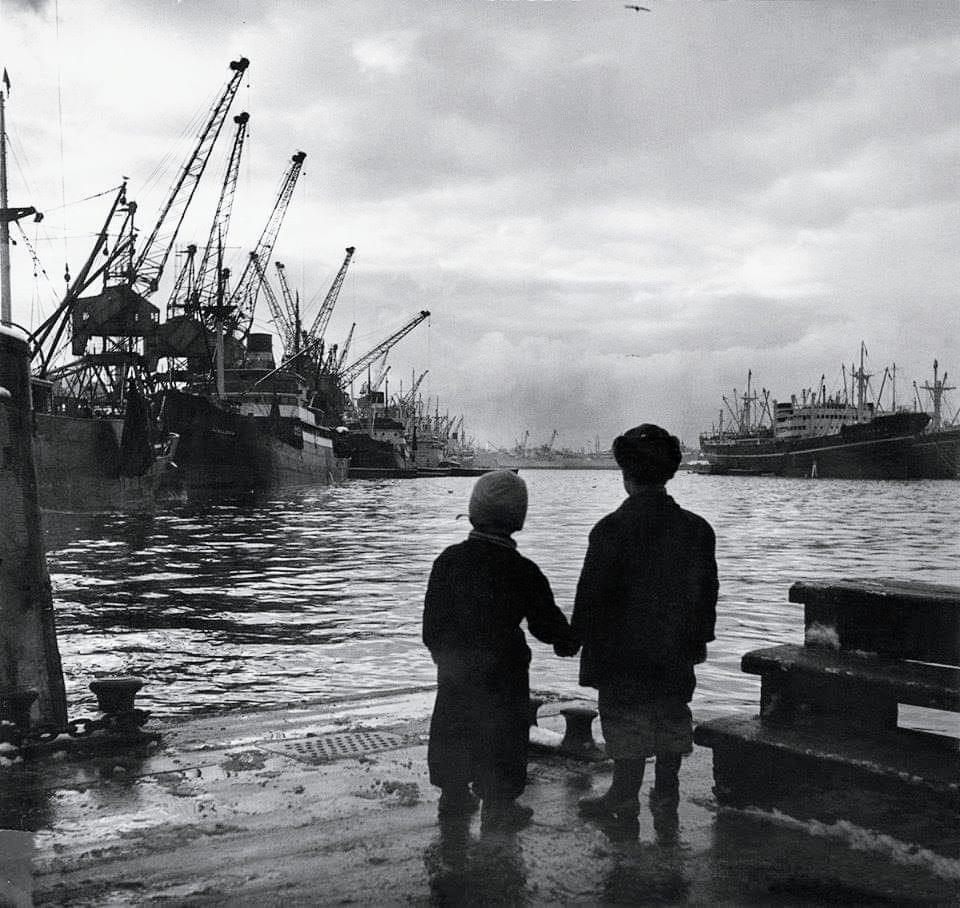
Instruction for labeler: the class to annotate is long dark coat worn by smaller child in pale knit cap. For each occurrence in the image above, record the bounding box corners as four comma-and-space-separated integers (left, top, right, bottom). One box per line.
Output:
423, 539, 576, 799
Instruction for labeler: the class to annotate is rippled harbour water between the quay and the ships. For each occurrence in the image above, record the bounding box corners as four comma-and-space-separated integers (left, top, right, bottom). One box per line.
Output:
44, 470, 960, 716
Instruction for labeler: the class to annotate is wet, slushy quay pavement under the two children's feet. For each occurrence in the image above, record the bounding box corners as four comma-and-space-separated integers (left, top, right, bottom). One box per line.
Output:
0, 690, 960, 906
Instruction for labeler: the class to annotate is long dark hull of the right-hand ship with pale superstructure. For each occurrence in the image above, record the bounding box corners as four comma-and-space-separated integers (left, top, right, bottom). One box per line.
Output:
701, 413, 946, 479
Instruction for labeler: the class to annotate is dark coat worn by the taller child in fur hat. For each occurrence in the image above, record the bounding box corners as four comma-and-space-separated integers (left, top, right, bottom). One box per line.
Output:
572, 487, 718, 702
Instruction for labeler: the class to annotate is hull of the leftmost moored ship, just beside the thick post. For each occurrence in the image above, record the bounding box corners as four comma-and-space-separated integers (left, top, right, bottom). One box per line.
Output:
33, 412, 173, 513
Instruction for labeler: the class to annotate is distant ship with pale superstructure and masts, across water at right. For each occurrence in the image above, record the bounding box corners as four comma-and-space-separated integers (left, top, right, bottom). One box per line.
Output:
700, 346, 950, 479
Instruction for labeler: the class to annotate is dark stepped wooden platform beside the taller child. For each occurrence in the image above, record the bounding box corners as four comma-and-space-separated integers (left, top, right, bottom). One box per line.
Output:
694, 580, 960, 857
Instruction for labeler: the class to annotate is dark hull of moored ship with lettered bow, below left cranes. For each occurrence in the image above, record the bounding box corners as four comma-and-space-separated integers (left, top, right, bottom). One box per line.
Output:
161, 391, 348, 497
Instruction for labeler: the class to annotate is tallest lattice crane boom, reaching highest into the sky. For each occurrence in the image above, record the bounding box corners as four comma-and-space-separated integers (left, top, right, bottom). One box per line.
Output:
132, 57, 250, 296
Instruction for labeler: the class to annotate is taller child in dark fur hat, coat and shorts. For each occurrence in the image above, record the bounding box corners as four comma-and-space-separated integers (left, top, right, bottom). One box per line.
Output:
572, 424, 718, 838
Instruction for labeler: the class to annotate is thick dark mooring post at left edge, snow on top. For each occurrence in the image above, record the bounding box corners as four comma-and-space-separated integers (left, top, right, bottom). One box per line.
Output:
0, 329, 67, 728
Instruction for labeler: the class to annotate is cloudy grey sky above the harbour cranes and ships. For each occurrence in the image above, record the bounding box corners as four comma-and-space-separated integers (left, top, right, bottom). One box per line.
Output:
0, 0, 960, 448
